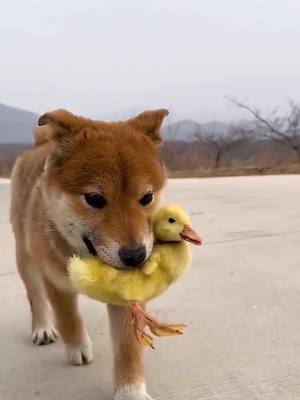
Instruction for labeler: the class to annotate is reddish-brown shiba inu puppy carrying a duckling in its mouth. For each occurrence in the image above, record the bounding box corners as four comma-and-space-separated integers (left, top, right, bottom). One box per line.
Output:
11, 109, 168, 400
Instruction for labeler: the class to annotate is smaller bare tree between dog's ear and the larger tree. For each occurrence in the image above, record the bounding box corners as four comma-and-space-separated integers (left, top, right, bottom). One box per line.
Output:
195, 125, 248, 169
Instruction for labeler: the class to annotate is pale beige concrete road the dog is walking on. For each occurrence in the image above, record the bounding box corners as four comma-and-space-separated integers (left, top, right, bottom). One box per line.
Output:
0, 176, 300, 400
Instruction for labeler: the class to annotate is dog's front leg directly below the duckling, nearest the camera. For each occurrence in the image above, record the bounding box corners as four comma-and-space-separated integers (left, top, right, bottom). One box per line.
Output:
108, 305, 152, 400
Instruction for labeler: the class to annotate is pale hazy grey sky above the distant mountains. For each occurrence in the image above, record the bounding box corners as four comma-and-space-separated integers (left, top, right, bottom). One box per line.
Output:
0, 0, 300, 122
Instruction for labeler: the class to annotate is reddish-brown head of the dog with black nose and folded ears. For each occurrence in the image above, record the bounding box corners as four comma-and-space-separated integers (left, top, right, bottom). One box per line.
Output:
35, 110, 168, 268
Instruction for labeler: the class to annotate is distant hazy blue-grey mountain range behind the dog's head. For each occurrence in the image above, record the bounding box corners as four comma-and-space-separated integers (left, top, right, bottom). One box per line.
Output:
0, 103, 229, 143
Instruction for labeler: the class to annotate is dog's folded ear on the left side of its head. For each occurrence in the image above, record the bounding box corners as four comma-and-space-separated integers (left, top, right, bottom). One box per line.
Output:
34, 109, 88, 144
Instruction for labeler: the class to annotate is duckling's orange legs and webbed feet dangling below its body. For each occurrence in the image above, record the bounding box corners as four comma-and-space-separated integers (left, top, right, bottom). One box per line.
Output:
128, 301, 185, 348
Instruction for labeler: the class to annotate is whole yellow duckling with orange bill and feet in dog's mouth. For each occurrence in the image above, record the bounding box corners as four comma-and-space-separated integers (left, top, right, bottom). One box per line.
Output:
69, 205, 202, 347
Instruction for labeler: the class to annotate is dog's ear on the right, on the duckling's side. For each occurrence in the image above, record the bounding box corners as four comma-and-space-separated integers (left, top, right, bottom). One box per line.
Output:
129, 108, 169, 144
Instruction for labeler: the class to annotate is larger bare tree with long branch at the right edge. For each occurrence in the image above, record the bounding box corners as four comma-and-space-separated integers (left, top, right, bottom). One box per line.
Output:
225, 97, 300, 163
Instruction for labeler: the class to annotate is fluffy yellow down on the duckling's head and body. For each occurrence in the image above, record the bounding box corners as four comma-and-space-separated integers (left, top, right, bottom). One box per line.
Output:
69, 205, 191, 305
